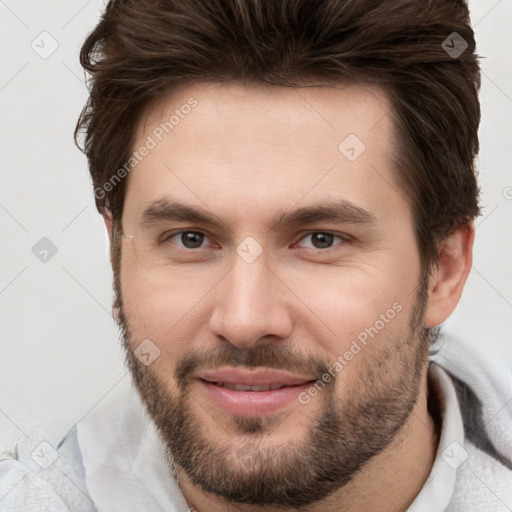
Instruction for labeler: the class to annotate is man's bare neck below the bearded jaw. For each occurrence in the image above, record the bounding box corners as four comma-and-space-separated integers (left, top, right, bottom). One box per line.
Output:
177, 364, 439, 512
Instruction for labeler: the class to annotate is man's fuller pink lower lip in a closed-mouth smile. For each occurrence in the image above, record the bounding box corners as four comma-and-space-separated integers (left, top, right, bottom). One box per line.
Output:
198, 379, 313, 416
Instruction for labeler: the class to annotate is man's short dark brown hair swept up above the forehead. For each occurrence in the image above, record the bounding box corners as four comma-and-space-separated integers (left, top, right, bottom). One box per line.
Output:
75, 0, 480, 271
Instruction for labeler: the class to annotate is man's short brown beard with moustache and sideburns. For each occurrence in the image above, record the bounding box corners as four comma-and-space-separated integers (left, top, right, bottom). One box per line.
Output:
114, 231, 428, 510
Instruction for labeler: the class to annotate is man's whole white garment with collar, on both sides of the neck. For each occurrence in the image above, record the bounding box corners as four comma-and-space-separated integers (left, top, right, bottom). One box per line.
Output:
0, 338, 512, 512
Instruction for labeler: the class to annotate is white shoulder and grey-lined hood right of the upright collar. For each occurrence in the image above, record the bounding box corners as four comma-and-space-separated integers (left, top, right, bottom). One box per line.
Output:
431, 338, 512, 512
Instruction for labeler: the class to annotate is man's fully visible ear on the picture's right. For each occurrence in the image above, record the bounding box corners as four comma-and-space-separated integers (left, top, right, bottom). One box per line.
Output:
424, 222, 475, 327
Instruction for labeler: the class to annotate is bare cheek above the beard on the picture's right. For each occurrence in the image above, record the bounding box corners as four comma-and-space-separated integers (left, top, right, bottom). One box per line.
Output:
283, 259, 419, 361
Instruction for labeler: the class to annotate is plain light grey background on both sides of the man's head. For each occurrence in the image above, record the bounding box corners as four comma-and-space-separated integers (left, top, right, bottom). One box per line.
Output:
0, 0, 512, 444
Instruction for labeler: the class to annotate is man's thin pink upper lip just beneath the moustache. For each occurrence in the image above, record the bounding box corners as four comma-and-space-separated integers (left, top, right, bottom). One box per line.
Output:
197, 368, 314, 386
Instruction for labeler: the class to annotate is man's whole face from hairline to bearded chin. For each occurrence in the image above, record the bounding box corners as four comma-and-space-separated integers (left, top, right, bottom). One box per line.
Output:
114, 84, 427, 508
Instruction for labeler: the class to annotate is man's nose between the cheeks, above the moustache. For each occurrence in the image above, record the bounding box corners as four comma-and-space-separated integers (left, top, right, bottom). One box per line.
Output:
210, 254, 292, 348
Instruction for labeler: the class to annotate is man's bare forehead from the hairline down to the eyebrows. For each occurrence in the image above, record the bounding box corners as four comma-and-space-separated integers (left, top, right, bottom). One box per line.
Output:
125, 83, 403, 226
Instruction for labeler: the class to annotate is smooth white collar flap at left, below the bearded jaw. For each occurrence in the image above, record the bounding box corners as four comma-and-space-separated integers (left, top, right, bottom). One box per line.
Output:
77, 387, 189, 512
